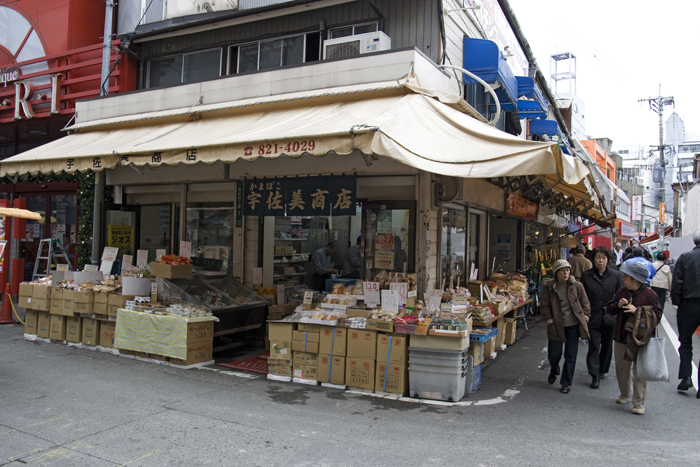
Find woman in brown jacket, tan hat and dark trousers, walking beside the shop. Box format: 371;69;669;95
540;259;591;394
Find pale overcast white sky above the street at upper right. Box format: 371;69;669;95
509;0;700;148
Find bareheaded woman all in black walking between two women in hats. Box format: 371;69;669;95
581;245;622;389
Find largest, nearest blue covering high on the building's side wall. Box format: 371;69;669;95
463;37;518;105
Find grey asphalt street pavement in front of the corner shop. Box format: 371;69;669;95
0;303;700;466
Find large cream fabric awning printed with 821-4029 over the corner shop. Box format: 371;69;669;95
0;79;590;186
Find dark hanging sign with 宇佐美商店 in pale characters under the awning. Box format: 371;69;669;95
243;176;357;216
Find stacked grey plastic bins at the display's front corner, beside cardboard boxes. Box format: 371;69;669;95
408;356;473;402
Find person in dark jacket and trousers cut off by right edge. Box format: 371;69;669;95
671;229;700;399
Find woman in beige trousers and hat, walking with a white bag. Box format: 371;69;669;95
606;263;663;415
